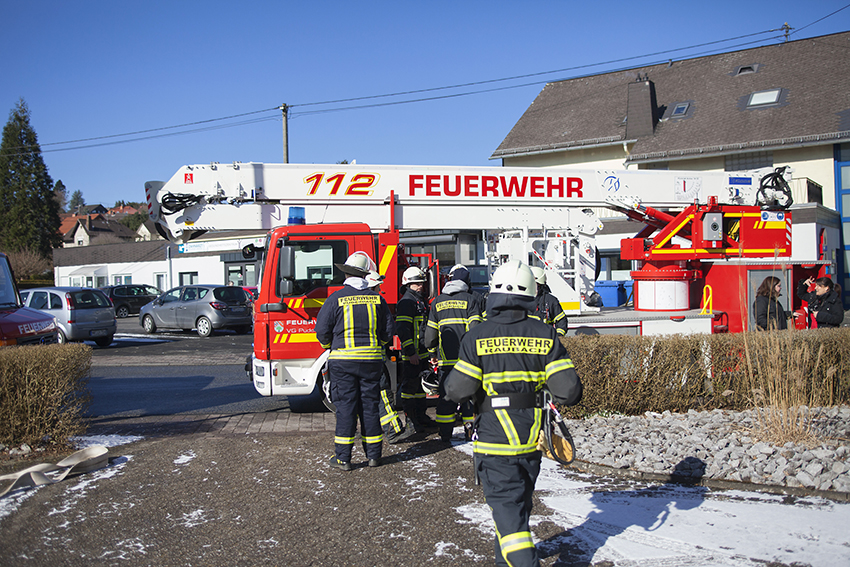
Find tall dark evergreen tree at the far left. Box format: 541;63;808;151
0;99;62;258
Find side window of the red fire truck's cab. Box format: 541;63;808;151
287;240;348;295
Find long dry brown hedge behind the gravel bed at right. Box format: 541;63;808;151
562;329;850;417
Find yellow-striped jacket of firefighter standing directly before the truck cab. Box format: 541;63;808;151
316;284;394;361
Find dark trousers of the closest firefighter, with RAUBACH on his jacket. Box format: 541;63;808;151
476;451;542;567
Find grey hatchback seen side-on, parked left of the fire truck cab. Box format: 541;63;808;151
139;285;252;337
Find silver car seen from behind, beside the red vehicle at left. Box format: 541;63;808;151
21;287;118;347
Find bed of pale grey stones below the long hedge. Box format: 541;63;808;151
568;406;850;492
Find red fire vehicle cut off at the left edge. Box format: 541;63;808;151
0;252;56;346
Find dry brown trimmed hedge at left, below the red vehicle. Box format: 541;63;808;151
0;344;91;447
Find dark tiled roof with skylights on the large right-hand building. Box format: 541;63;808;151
491;32;850;162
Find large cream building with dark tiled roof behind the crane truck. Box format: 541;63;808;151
491;32;850;304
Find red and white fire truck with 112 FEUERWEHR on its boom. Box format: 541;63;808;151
145;162;825;408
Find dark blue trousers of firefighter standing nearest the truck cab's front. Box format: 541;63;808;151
328;359;384;463
